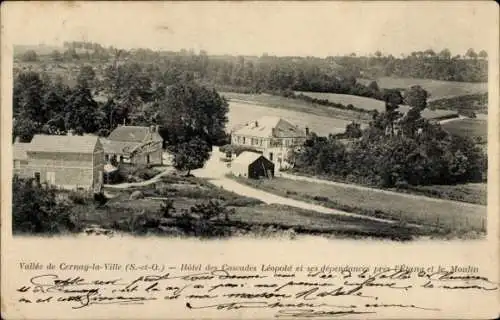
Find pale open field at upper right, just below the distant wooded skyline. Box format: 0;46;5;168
358;77;488;100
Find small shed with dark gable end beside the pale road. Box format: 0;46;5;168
231;151;274;179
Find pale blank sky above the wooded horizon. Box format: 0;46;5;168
1;1;498;57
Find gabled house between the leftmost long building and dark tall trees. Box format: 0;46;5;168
101;126;163;165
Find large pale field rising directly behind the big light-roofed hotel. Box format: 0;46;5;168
222;92;366;135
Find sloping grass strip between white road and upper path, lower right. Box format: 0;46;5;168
231;178;486;232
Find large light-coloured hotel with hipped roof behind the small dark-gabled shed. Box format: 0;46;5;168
231;116;309;170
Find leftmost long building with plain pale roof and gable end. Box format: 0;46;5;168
13;135;104;192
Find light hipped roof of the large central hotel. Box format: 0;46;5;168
234;116;306;138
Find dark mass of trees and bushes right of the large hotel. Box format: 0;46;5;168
292;86;487;188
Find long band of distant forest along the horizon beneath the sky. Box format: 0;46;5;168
16;42;488;94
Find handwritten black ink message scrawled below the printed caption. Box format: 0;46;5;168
16;268;498;318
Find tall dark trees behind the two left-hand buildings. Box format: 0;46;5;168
13;64;229;173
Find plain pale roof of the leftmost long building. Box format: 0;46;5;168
27;134;99;153
